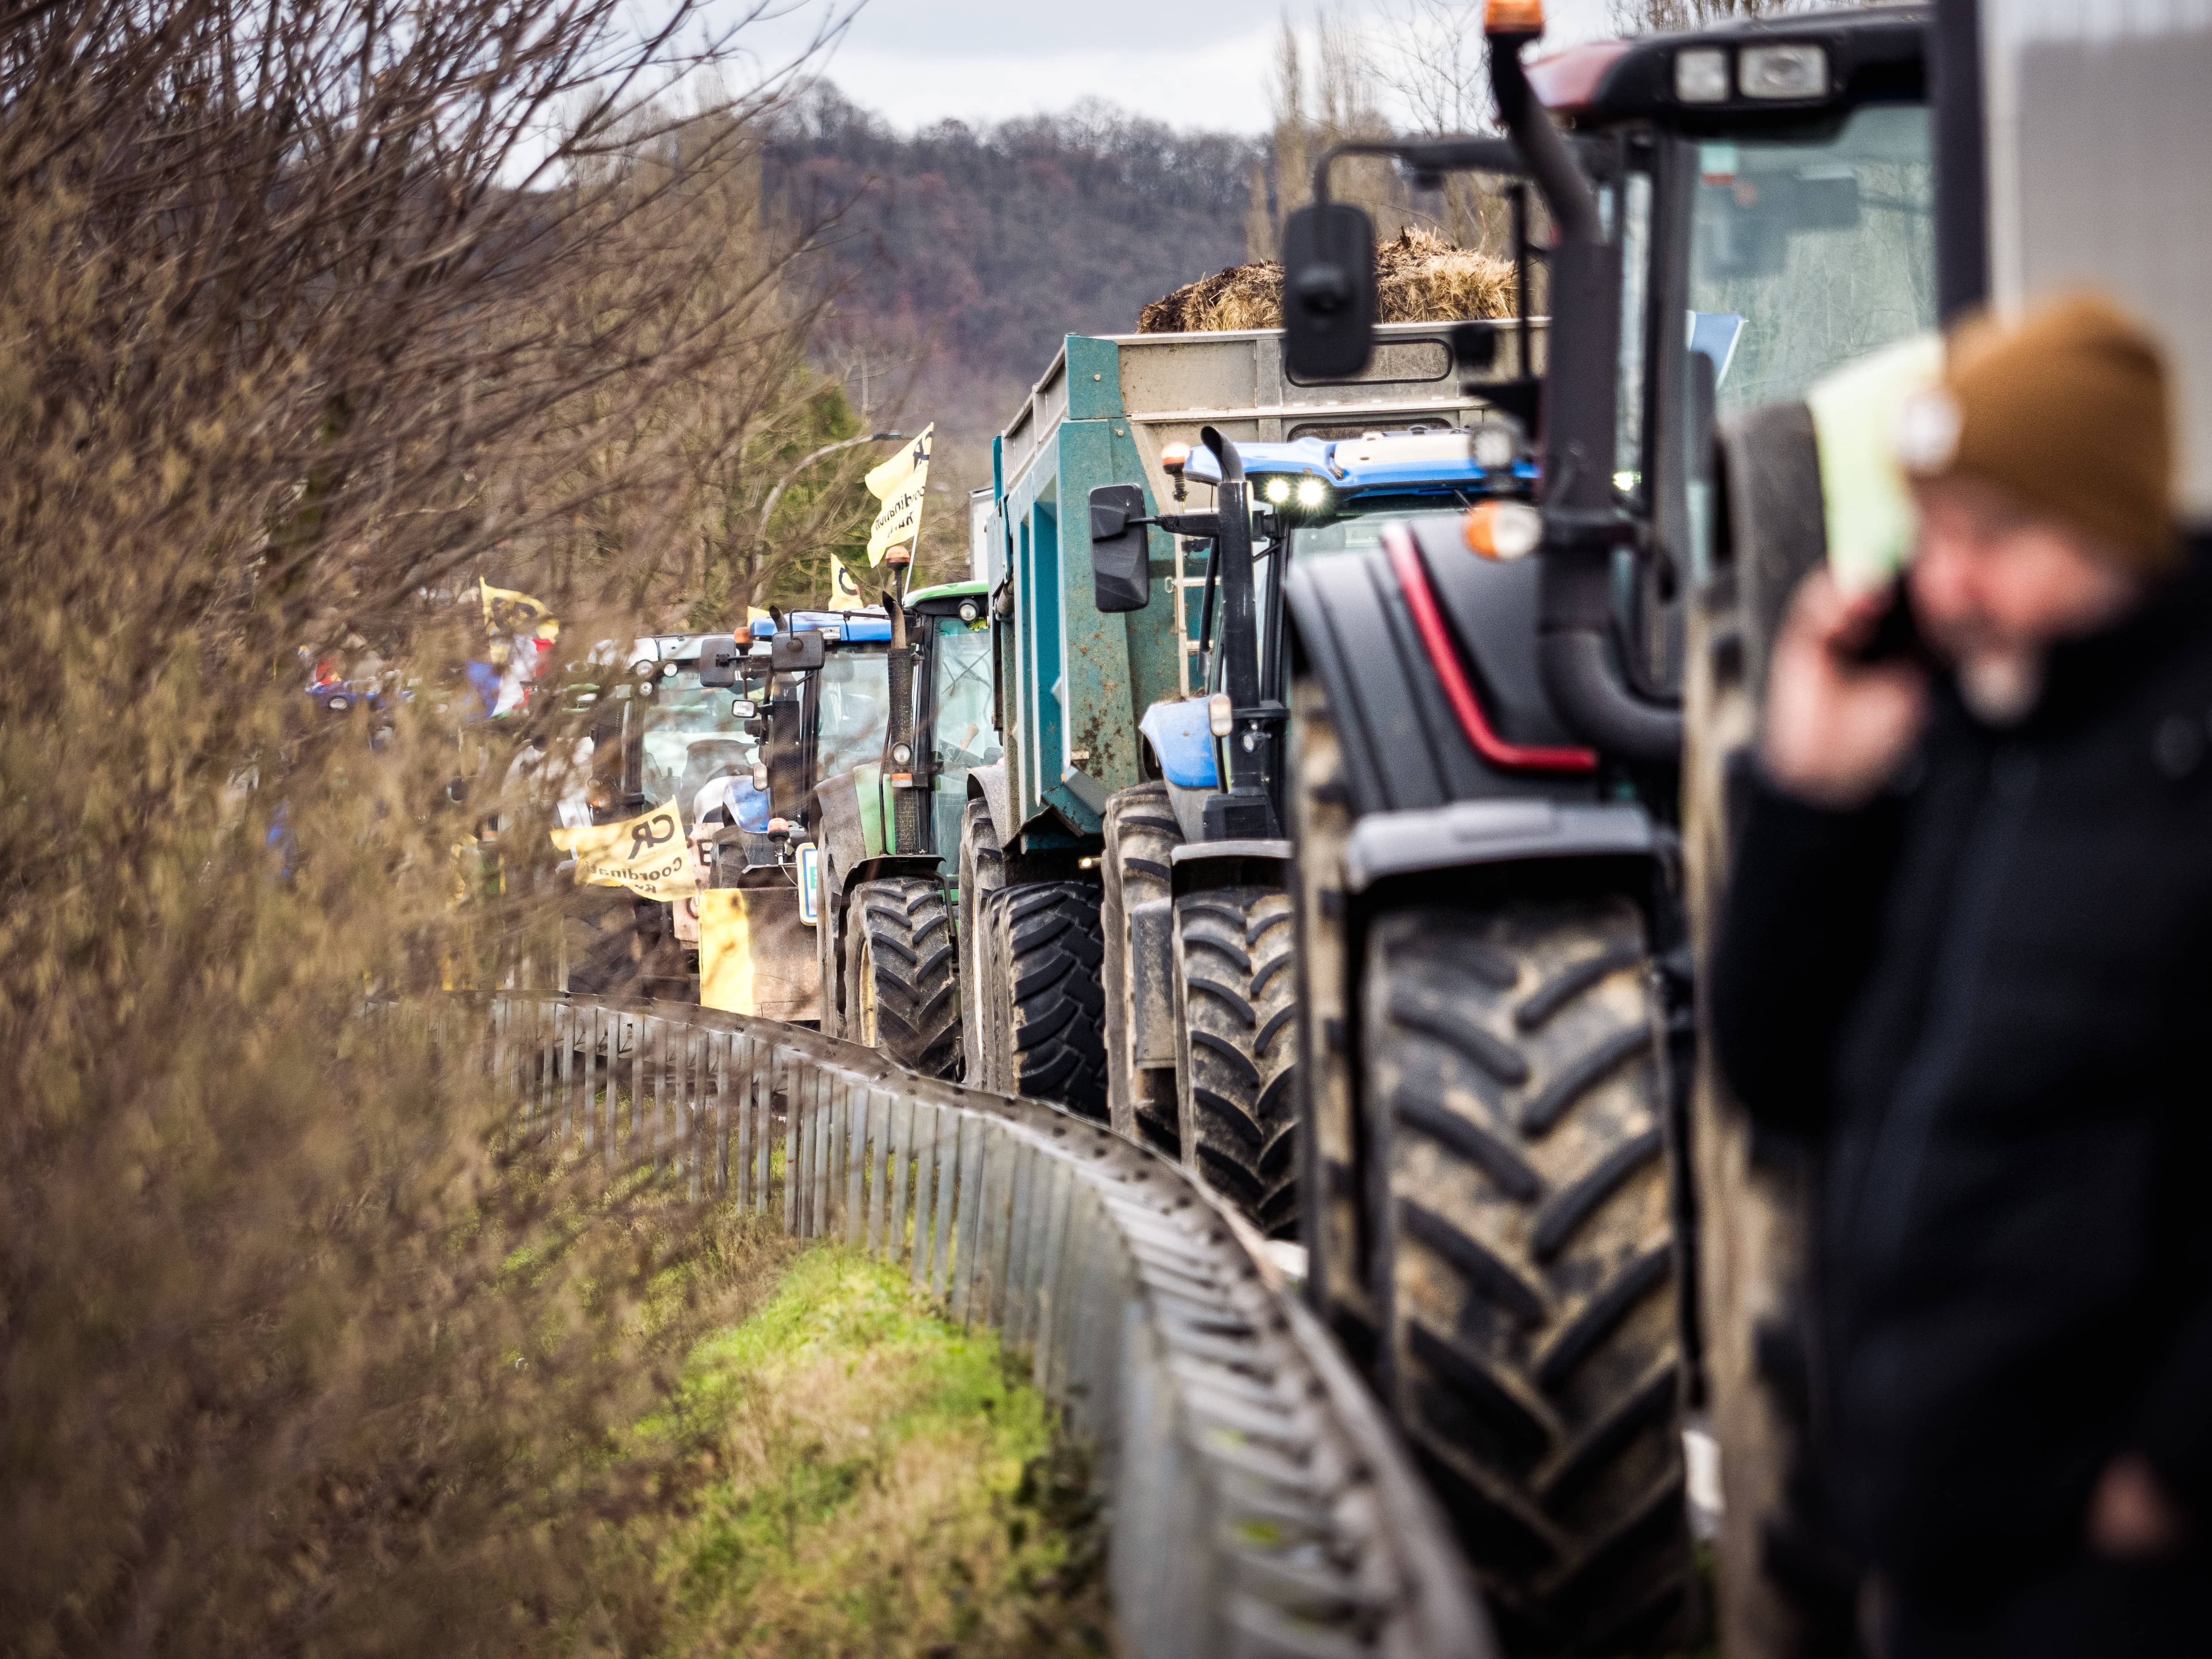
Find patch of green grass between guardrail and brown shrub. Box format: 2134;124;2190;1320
661;1245;1108;1659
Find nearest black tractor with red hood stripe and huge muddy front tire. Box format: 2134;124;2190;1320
1285;7;1936;1652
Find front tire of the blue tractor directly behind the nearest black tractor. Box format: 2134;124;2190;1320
1175;887;1298;1239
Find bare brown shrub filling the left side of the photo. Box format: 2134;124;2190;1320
0;0;854;1655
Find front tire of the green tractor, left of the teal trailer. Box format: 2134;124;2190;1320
845;876;960;1077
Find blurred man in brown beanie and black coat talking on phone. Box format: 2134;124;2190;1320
1712;299;2212;1659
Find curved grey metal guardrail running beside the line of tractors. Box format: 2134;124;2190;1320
491;995;1498;1659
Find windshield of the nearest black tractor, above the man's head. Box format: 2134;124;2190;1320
1688;104;1936;409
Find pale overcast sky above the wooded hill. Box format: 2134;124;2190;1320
719;0;1610;133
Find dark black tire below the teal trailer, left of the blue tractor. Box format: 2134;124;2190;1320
980;880;1106;1121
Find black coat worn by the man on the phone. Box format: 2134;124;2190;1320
1710;568;2212;1593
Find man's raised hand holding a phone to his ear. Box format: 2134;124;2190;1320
1761;571;1929;810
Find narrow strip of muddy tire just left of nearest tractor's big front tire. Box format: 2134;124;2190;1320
1290;675;1382;1382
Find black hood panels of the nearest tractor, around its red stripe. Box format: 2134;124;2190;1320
1285;520;1597;816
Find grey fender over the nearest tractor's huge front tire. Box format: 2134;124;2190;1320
1345;799;1663;894
